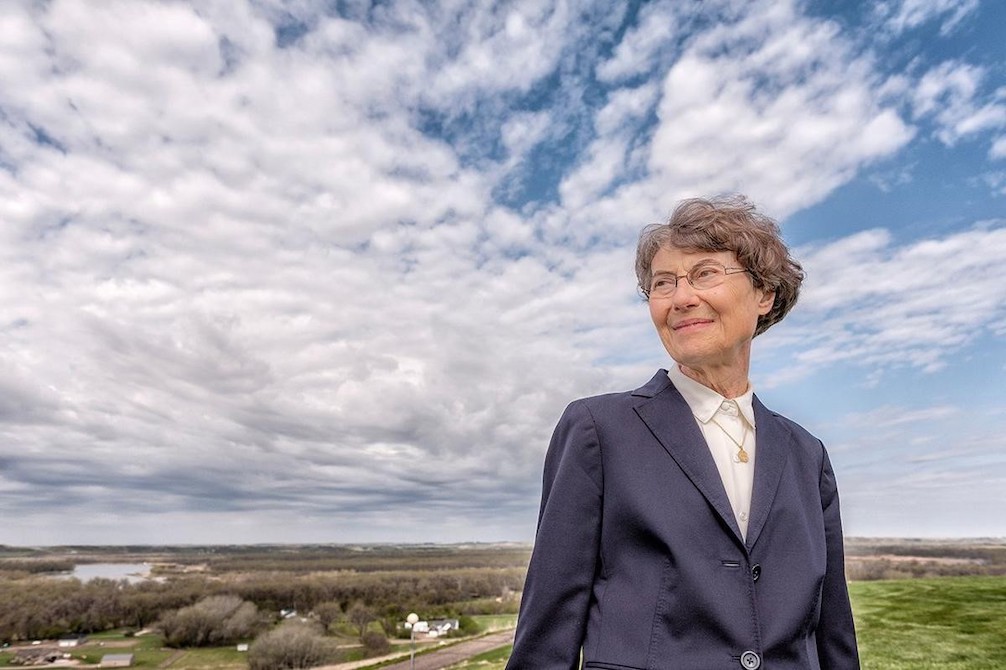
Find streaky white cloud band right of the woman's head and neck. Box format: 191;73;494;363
763;223;1006;385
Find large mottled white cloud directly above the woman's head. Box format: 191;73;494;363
591;3;912;227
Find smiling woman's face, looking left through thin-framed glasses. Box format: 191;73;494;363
649;246;776;375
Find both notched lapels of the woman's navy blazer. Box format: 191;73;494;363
632;369;791;547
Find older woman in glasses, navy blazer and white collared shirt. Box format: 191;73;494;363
507;196;859;670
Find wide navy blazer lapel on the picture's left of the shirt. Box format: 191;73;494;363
633;370;744;543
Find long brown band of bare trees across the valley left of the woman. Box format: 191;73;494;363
0;567;524;642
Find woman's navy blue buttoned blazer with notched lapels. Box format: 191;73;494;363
507;370;859;670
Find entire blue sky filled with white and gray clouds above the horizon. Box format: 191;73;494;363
0;0;1006;546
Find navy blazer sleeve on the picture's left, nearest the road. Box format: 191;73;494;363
506;400;603;670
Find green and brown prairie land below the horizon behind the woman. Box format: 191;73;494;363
0;538;1006;670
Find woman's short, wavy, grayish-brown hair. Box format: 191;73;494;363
636;194;805;335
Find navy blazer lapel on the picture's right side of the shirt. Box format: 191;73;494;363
747;396;792;547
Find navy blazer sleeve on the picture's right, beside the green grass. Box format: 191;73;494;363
816;447;859;670
